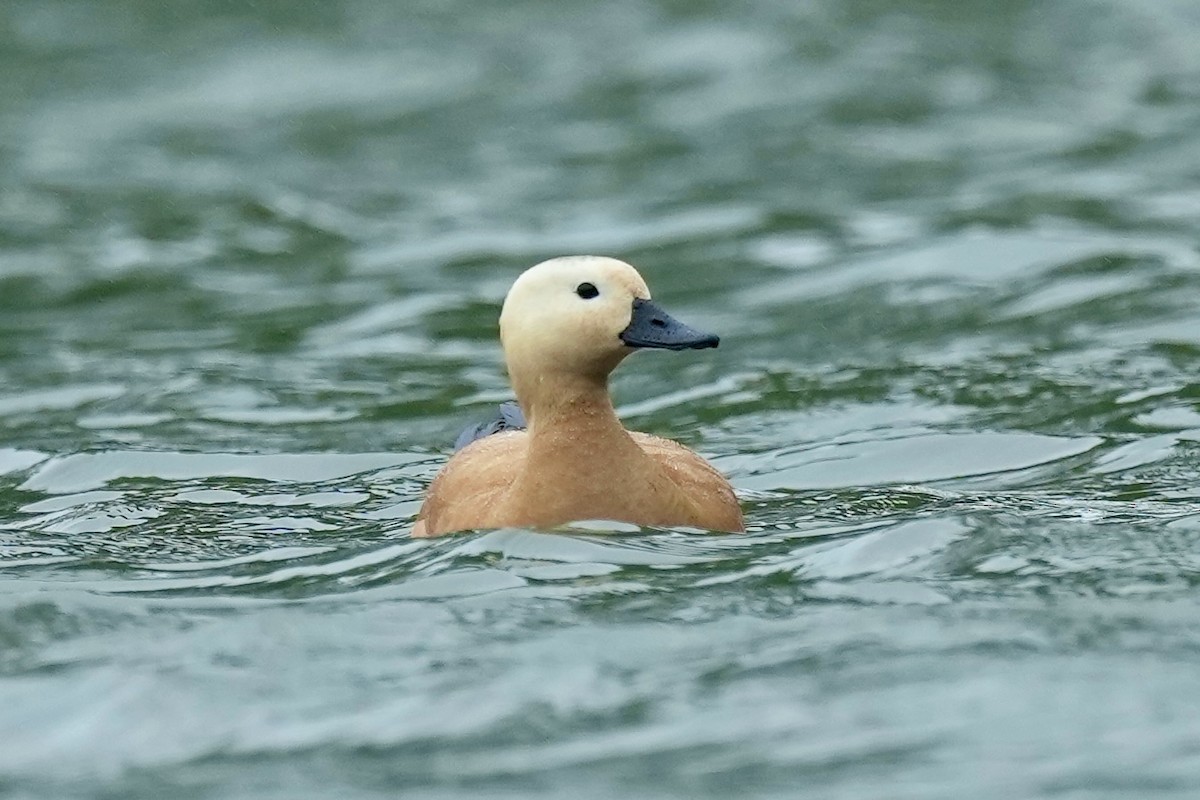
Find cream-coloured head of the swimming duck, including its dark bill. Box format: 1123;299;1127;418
500;255;720;378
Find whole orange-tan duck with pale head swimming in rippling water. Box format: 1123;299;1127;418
412;255;745;537
